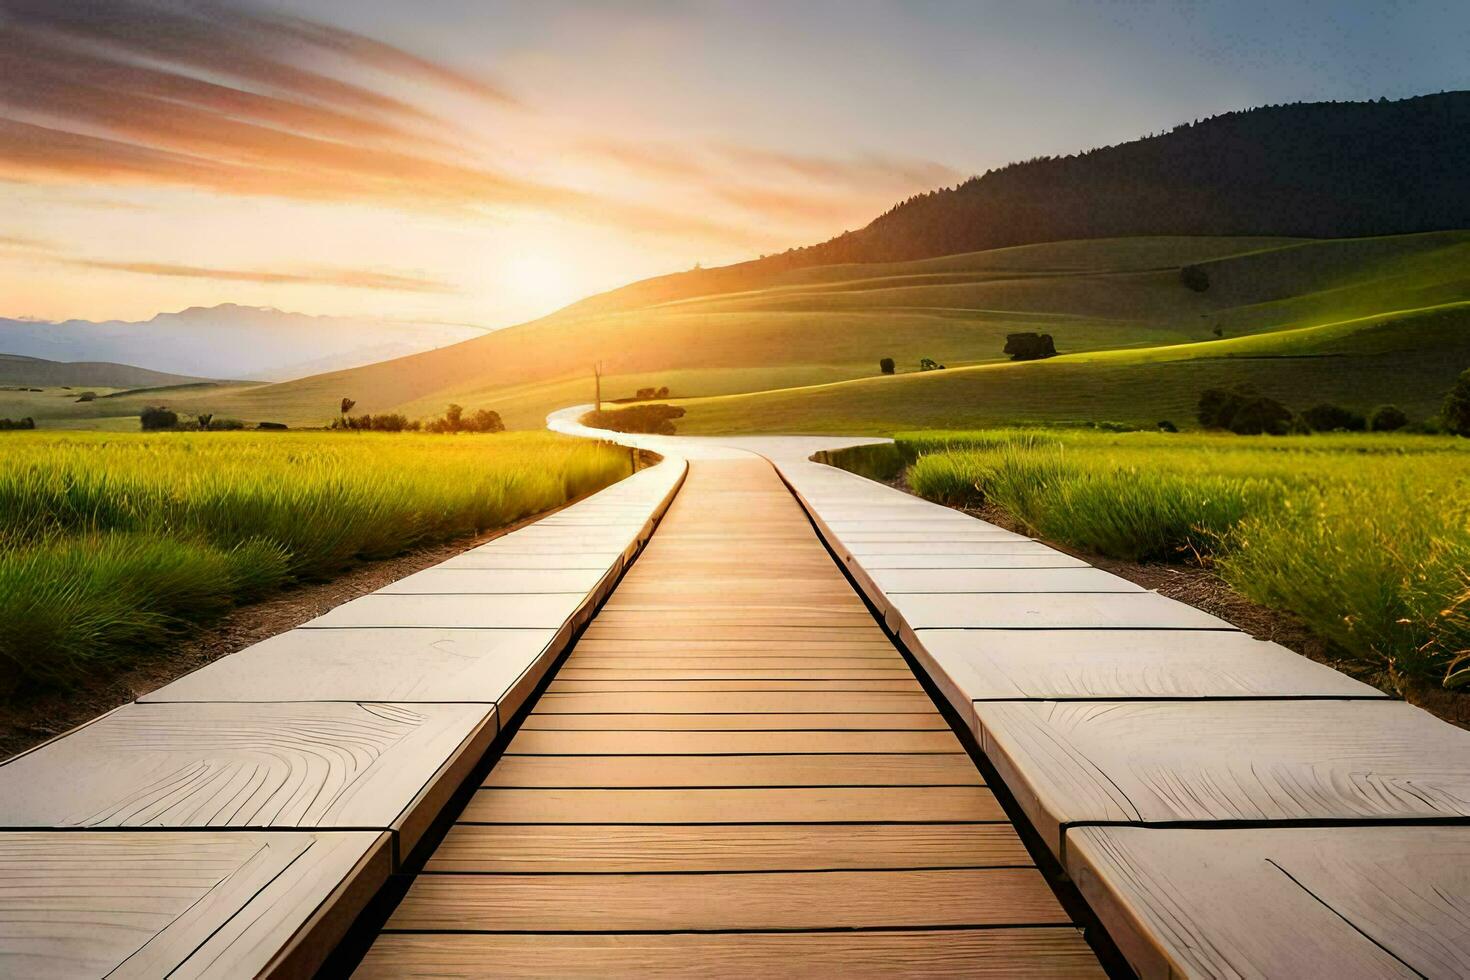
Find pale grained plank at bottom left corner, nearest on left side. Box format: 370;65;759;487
0;832;390;977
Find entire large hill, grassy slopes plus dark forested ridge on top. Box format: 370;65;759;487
14;94;1470;430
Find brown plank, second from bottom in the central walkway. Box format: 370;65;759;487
387;868;1069;933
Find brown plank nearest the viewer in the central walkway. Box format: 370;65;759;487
354;929;1105;980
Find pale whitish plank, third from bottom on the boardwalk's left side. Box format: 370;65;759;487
140;629;557;702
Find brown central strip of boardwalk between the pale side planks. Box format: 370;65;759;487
357;458;1103;977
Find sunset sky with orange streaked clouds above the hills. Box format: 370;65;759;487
0;0;1470;328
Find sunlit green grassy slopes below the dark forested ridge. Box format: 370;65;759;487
22;232;1470;432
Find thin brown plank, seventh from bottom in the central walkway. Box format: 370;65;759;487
520;711;950;732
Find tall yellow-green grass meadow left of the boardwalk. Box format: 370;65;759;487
0;432;629;695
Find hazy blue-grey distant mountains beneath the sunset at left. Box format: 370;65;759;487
0;303;484;383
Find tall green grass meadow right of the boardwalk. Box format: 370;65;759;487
836;429;1470;686
